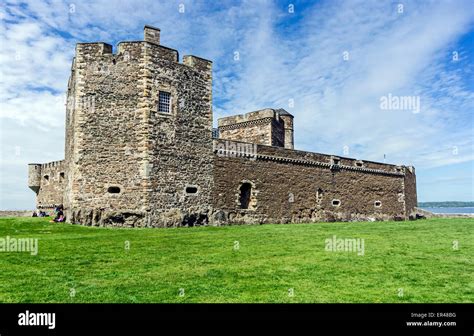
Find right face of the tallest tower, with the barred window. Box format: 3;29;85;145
146;50;213;227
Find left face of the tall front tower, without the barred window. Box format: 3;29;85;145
66;42;148;225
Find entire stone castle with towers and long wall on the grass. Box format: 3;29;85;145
28;26;417;227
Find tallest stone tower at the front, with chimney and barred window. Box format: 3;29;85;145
64;26;213;226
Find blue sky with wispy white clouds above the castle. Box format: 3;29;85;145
0;0;474;210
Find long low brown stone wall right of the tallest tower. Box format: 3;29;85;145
213;140;416;223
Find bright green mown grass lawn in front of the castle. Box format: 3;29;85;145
0;218;474;302
